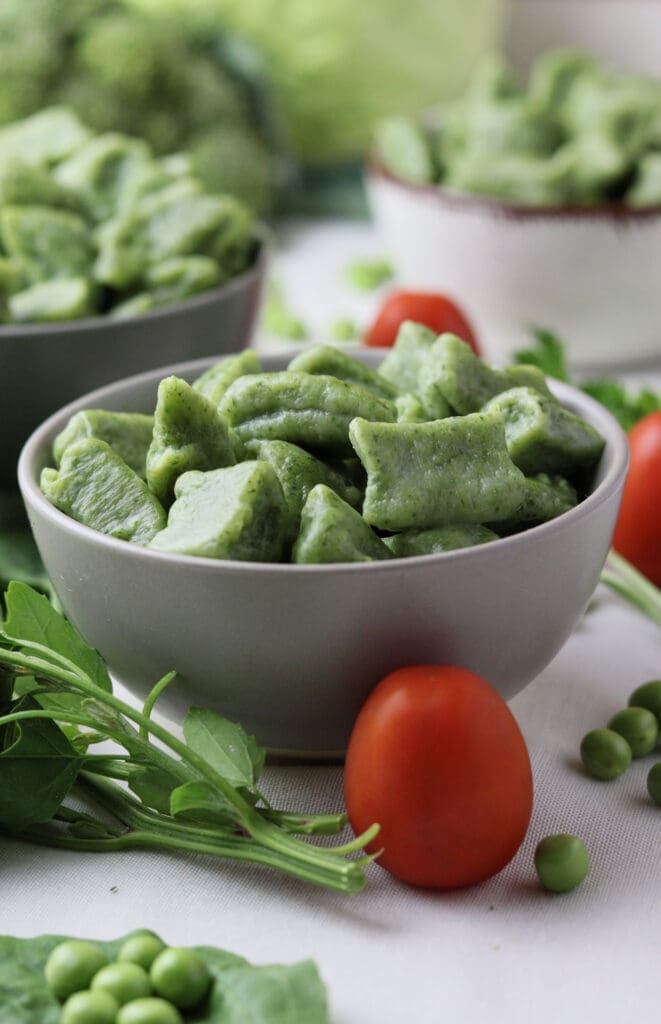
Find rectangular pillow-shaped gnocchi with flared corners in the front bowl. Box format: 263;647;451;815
349;410;525;531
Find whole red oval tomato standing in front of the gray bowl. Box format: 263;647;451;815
345;665;532;889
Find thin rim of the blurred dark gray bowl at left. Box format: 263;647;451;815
0;223;271;342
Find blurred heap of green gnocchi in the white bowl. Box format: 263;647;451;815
377;50;661;208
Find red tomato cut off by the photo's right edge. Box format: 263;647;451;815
613;412;661;587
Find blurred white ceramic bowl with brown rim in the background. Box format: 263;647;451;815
367;166;661;370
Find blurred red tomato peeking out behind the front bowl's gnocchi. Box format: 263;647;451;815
364;292;481;355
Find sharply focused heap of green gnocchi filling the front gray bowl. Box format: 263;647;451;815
41;322;604;563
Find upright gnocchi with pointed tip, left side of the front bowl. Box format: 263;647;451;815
146;376;236;506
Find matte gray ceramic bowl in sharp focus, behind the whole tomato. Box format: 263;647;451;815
18;349;627;757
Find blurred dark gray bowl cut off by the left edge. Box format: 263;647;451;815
0;239;268;490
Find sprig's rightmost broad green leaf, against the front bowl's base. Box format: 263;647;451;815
183;708;265;790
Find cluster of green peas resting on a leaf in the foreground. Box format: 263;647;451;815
45;933;212;1024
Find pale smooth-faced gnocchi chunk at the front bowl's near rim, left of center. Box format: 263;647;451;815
149;460;288;562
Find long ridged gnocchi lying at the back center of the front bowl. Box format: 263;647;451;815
219;370;397;455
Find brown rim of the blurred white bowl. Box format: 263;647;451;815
366;156;661;221
